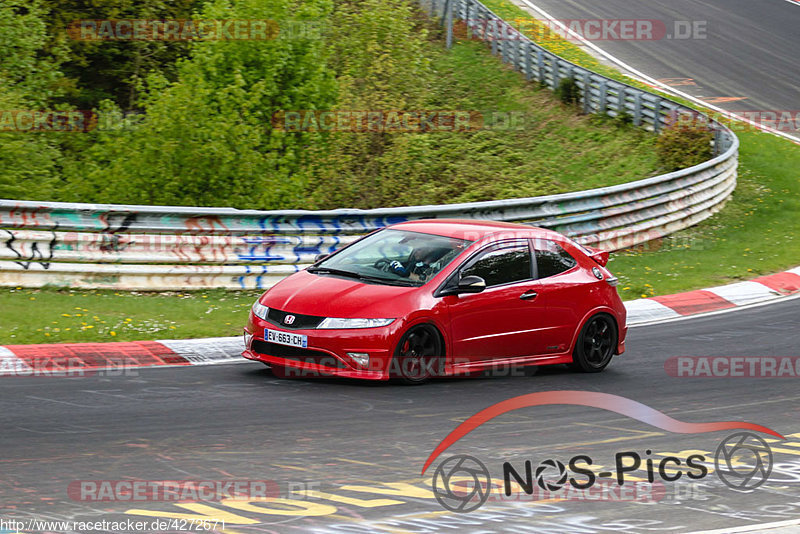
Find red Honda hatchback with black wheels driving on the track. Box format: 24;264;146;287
243;219;627;384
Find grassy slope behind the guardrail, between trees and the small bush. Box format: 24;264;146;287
306;36;662;209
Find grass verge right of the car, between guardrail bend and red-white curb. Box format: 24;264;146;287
609;127;800;300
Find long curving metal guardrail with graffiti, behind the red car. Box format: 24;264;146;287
0;0;739;290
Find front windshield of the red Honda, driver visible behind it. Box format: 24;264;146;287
308;229;473;286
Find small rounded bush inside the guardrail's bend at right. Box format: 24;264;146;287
656;119;714;172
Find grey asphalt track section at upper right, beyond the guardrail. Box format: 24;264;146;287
515;0;800;136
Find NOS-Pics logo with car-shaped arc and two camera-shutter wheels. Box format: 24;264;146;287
422;391;785;513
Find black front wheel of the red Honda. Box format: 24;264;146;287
392;324;443;385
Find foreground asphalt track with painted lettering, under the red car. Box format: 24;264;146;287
0;298;800;533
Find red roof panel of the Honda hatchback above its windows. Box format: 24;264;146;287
391;219;563;241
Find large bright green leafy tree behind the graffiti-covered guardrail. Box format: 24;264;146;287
64;0;335;208
